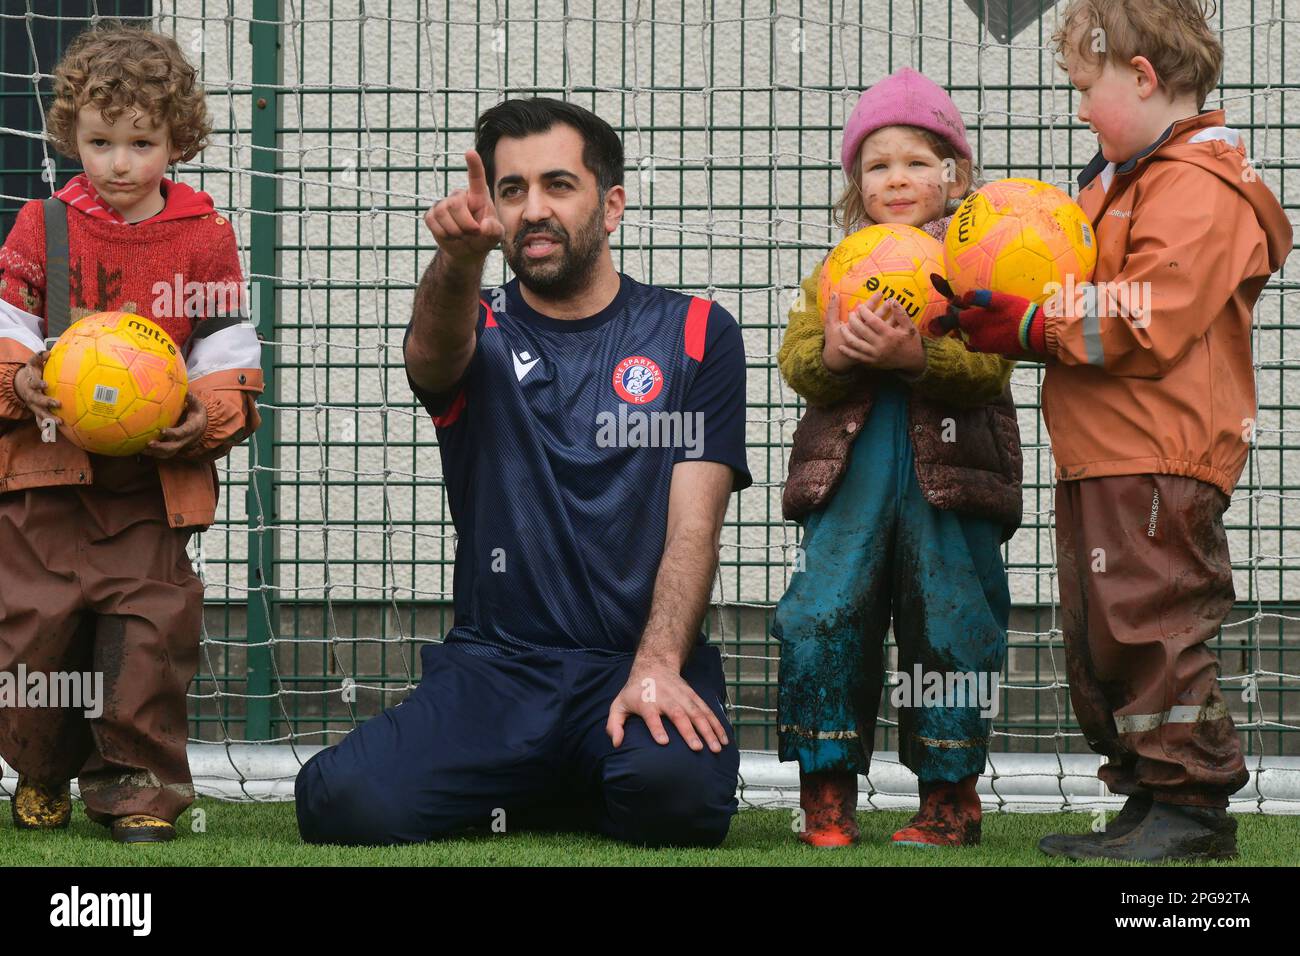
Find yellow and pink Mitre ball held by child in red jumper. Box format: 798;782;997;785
44;312;189;457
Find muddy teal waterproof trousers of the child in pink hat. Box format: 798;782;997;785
772;382;1010;782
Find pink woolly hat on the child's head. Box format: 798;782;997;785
840;66;972;176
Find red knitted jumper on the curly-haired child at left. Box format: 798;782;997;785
0;177;243;347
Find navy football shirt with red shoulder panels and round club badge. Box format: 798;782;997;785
403;276;751;653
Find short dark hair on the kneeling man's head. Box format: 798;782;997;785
475;96;623;196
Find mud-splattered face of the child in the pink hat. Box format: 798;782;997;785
858;126;962;226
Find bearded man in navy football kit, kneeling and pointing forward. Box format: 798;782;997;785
289;99;750;845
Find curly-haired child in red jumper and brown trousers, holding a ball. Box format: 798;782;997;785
0;23;263;843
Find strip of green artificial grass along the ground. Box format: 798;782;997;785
0;800;1300;866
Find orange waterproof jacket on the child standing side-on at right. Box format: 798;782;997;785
1043;109;1291;494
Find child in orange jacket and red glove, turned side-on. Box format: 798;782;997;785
952;0;1294;862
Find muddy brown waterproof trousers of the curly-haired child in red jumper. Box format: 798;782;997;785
0;477;203;823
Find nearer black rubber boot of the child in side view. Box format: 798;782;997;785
1065;803;1236;862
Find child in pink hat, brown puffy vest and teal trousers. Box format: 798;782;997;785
772;68;1021;847
